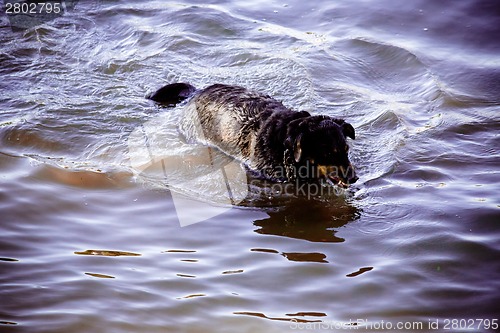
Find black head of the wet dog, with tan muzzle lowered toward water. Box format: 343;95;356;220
285;116;358;188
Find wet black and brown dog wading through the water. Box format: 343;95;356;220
147;83;358;188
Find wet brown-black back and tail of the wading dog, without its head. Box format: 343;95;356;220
149;83;294;168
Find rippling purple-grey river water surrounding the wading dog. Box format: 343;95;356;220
0;0;500;333
